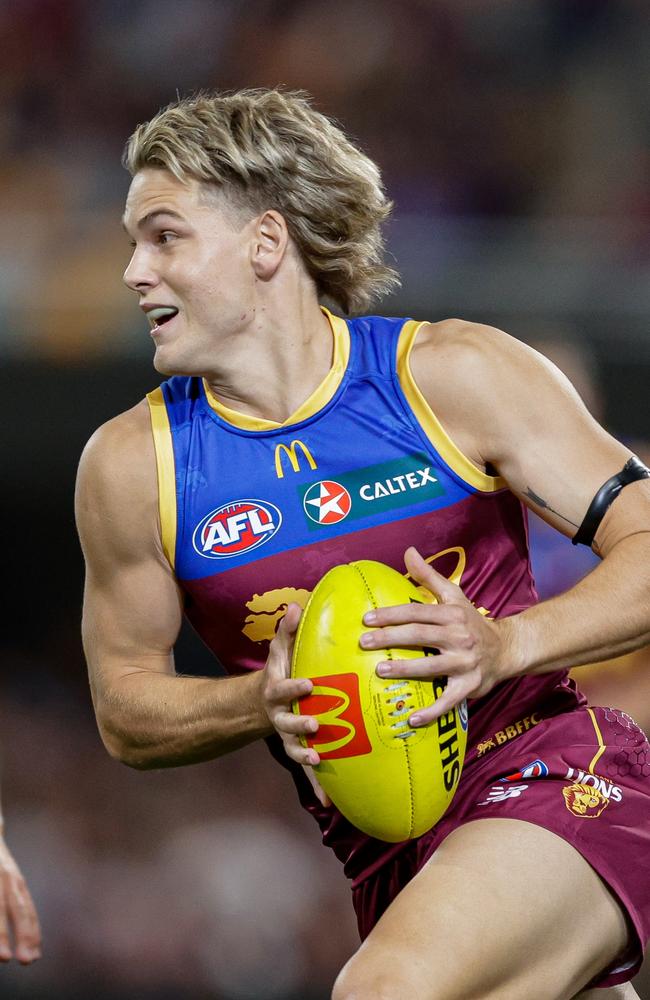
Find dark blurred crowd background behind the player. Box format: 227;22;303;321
0;0;650;1000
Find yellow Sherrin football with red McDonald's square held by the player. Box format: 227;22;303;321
291;560;467;843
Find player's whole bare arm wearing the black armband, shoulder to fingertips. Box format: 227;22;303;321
362;321;650;721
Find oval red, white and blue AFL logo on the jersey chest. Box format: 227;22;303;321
192;500;282;559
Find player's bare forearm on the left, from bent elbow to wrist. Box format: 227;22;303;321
94;670;272;769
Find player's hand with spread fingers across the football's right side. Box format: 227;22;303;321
360;548;513;726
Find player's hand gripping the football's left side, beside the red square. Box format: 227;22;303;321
262;604;320;767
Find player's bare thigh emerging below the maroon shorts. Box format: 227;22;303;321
333;819;628;1000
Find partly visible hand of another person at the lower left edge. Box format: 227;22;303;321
0;832;41;965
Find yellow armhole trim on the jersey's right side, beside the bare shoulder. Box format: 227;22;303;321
397;320;506;493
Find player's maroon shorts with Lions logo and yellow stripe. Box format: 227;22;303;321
353;708;650;986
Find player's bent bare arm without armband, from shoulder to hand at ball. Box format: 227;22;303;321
76;404;312;768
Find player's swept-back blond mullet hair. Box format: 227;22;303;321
123;89;399;312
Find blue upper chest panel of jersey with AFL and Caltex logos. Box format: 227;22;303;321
163;317;474;580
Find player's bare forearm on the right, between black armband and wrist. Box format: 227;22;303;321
498;532;650;673
